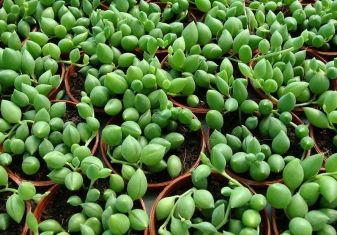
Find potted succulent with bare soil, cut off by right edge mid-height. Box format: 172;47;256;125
304;91;337;159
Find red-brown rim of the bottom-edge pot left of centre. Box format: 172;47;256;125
30;185;148;235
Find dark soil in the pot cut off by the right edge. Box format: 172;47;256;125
314;128;337;156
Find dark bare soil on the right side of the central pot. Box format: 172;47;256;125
147;126;202;183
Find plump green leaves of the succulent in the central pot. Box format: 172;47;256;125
102;98;201;180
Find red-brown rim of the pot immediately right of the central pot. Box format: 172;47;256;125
206;113;311;188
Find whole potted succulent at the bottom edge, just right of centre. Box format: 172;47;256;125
150;155;271;235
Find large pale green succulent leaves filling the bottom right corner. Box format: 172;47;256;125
266;154;337;235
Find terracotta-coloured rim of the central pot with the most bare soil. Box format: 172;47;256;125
100;120;206;190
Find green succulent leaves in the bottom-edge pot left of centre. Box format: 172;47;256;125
27;171;148;235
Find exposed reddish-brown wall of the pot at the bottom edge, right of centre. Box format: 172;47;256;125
150;172;271;235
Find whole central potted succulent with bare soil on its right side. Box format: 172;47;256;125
101;91;205;189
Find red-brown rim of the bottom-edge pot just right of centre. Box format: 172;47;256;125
149;172;271;235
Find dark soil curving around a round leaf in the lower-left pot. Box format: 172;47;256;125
9;155;50;181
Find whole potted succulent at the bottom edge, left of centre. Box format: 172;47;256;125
28;161;148;235
